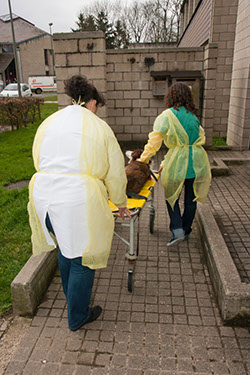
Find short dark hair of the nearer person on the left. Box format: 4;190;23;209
64;74;105;106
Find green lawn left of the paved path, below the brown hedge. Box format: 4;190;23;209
0;104;58;315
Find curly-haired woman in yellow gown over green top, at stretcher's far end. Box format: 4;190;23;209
138;83;211;246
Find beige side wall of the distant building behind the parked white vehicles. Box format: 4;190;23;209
20;34;53;83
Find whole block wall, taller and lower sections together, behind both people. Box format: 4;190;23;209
54;32;212;144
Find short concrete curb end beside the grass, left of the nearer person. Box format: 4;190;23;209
11;249;58;316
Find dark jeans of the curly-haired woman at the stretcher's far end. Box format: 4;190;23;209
166;178;197;235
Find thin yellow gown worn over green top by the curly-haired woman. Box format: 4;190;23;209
139;109;211;209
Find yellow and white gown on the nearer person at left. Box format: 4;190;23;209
28;105;127;269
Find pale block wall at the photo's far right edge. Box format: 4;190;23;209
227;0;250;149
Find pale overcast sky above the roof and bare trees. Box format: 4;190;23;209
0;0;133;33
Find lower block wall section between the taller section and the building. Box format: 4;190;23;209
107;48;203;141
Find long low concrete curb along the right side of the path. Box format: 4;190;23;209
196;204;250;325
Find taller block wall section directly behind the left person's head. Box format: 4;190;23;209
53;31;107;119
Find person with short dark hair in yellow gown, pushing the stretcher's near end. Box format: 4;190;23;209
28;75;130;331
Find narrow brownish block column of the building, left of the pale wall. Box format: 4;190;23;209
209;0;238;137
